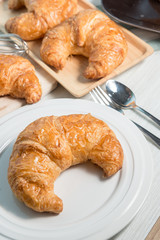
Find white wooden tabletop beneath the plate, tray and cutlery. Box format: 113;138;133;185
0;0;160;240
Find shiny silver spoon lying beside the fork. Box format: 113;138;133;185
106;80;160;126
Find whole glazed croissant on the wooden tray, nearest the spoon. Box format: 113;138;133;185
41;9;127;79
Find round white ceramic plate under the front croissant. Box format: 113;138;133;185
0;99;152;240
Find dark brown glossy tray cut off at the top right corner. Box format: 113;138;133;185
102;0;160;33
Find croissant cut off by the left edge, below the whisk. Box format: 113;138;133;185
0;54;42;103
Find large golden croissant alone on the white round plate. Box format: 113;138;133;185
8;114;123;213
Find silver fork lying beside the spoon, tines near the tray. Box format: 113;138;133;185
90;86;160;147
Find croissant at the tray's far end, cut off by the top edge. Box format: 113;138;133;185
5;0;77;40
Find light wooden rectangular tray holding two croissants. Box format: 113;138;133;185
0;0;153;97
